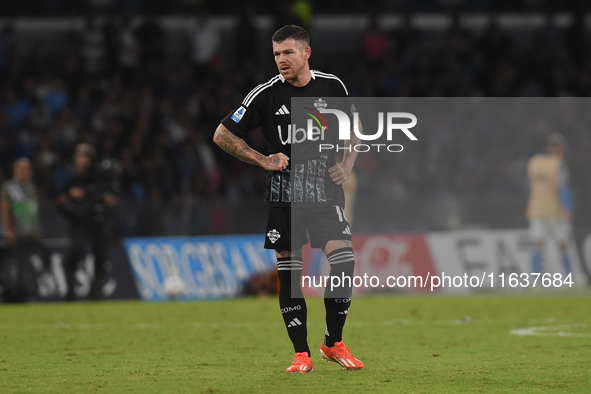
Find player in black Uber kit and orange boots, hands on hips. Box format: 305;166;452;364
214;25;363;373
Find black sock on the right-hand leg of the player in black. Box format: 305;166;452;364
324;248;355;347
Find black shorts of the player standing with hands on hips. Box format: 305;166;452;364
265;205;351;250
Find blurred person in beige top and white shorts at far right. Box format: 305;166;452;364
526;133;573;275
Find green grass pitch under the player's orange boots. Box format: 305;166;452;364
0;292;591;393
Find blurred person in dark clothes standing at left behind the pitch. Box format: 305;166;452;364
58;143;118;301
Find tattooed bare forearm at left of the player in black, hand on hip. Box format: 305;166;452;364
213;124;289;171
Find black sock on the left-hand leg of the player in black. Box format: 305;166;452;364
277;257;310;356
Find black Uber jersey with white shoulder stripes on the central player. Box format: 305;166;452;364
222;70;348;207
